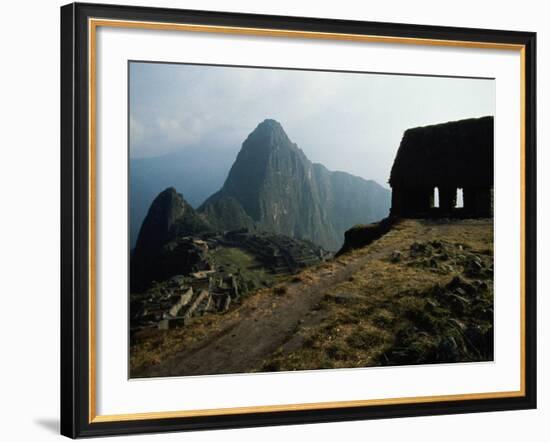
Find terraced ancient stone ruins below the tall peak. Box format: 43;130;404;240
130;229;332;333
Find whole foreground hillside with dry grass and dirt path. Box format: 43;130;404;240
130;219;493;377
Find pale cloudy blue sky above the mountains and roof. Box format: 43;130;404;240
129;62;495;187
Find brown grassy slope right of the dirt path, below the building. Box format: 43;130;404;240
260;220;493;371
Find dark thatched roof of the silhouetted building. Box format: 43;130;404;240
389;117;494;187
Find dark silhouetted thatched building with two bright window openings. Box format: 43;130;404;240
389;117;494;218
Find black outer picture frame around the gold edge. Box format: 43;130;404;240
61;3;536;438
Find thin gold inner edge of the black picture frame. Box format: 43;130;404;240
88;18;526;423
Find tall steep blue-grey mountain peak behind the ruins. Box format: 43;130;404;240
198;119;390;251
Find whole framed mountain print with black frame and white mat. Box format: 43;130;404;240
61;4;536;438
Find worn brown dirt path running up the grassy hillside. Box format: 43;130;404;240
147;248;391;376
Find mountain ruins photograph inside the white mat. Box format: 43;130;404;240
128;60;498;379
